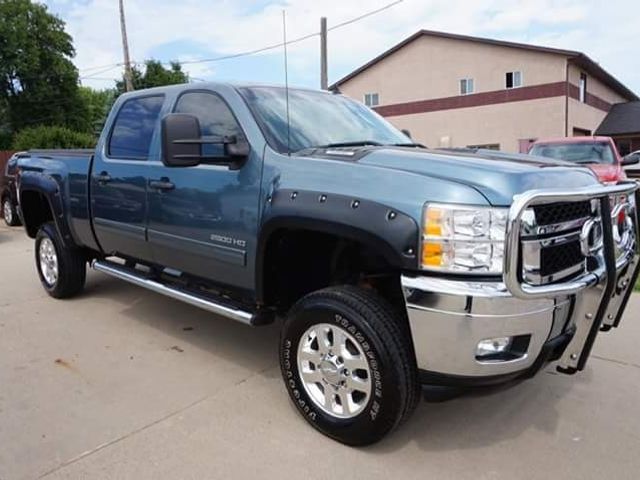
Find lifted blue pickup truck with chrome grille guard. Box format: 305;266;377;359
17;83;639;445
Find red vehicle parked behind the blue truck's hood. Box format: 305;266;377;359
529;137;631;184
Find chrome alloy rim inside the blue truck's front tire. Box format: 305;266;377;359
297;323;372;418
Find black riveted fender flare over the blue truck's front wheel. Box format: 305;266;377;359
255;189;420;303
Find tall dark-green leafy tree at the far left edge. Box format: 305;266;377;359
0;0;90;131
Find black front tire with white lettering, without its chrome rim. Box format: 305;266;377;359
280;286;419;446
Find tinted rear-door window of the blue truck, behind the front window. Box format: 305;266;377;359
109;96;164;160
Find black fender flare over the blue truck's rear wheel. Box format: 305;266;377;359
18;170;75;246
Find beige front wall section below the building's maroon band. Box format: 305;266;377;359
387;97;565;152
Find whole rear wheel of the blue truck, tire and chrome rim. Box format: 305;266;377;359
35;223;87;298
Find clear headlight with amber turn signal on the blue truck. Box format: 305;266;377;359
421;203;509;274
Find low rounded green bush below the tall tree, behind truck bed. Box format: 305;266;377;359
13;125;96;150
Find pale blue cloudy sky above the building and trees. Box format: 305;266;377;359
44;0;640;93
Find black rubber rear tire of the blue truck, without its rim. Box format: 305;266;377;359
35;223;87;298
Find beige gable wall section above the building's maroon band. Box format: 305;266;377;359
340;36;566;105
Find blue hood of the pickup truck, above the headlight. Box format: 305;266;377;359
357;147;598;206
